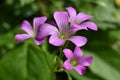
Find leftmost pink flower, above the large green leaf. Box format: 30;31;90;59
15;16;47;45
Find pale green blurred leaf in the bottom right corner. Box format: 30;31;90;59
84;49;120;80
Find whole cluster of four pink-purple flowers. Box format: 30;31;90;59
15;7;97;75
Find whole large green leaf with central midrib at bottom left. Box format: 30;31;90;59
0;44;55;80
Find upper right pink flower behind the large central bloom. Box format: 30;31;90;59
66;7;97;31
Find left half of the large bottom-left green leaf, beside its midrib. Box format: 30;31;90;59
0;47;26;80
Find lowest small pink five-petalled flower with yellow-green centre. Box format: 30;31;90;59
63;47;93;75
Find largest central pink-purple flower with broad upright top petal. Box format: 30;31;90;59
36;12;87;47
